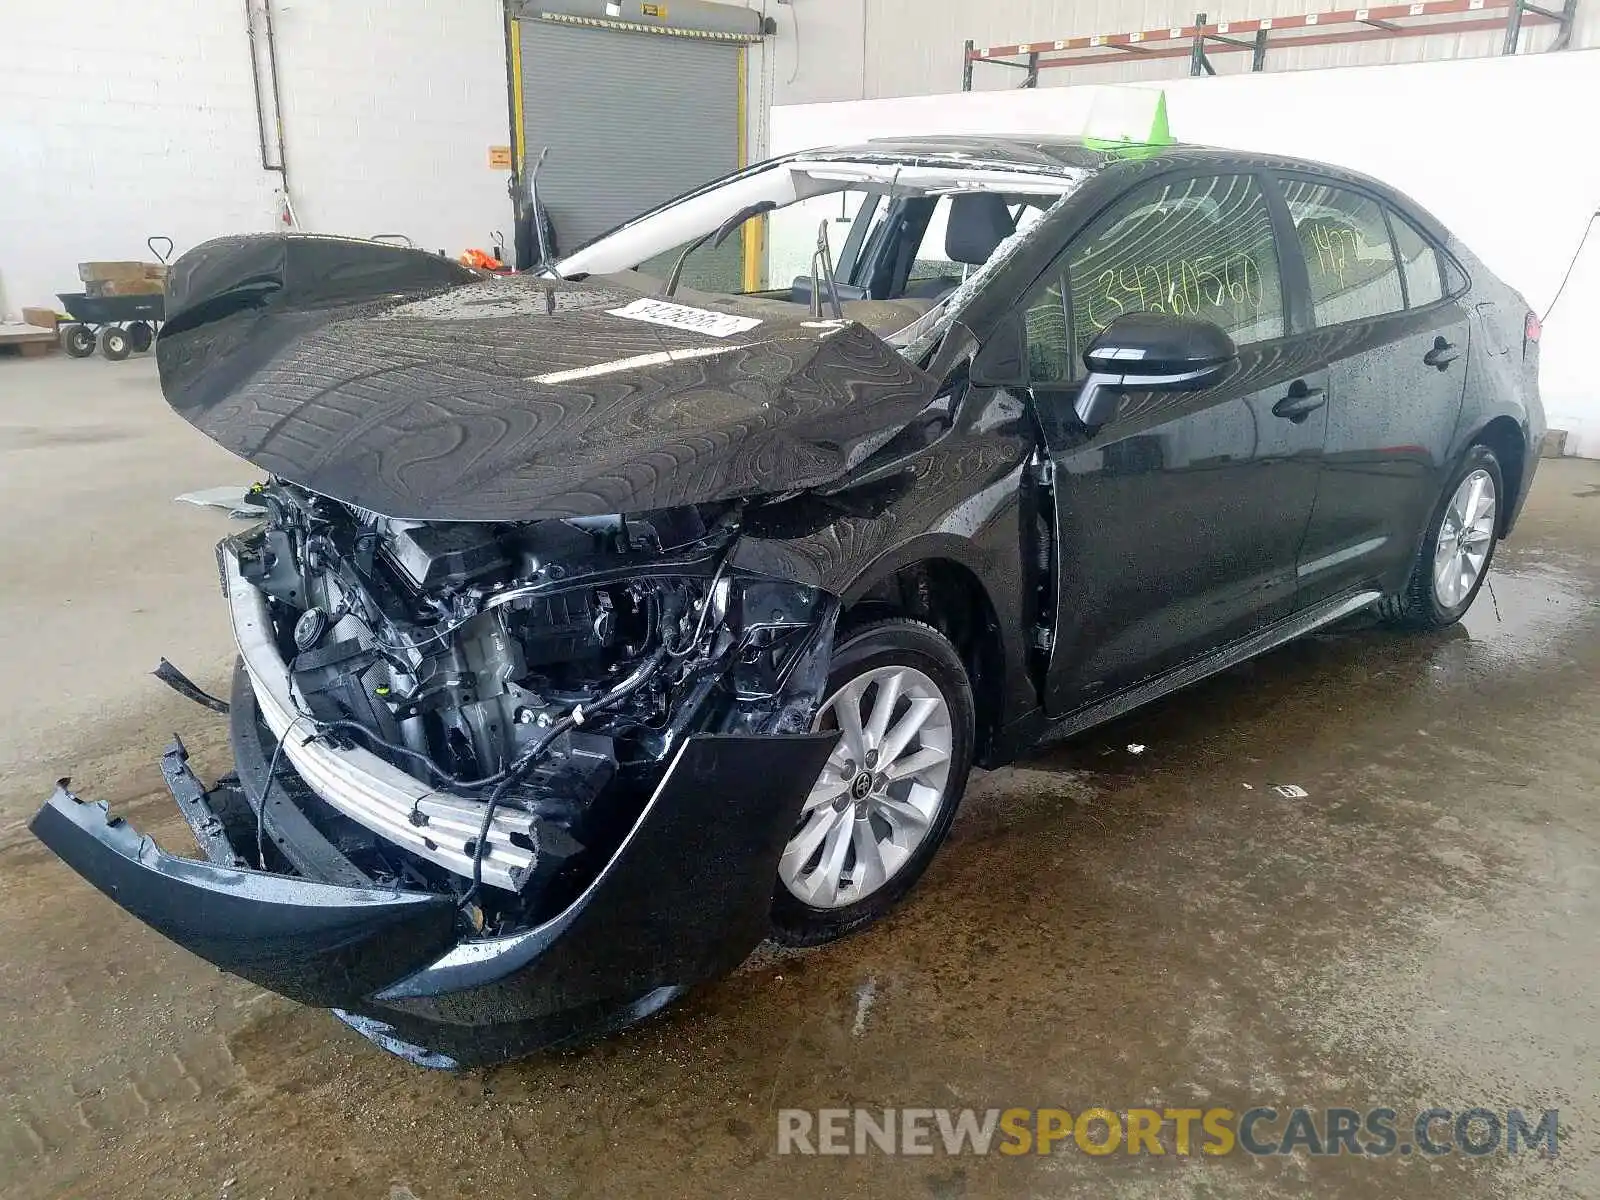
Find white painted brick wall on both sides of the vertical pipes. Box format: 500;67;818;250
0;0;510;315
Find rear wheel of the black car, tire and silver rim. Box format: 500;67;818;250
1378;446;1506;629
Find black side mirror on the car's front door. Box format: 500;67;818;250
1072;312;1238;430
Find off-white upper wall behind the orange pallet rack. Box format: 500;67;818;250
766;0;1600;104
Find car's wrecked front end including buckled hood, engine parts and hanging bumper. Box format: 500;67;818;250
34;235;972;1064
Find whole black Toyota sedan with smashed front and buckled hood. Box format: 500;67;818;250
32;138;1544;1066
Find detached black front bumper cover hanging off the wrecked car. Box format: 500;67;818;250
30;733;837;1067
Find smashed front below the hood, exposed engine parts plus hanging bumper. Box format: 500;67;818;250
34;480;838;1066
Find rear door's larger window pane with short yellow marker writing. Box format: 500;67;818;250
1283;181;1405;325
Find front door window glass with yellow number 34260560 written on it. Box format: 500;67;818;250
1026;174;1283;381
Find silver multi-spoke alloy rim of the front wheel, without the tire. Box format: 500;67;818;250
778;666;954;909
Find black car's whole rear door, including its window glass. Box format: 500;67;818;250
1280;173;1469;606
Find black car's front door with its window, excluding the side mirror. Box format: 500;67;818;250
1026;174;1326;714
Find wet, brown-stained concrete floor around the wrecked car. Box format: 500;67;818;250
0;358;1600;1200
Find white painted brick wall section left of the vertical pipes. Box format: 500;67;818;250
0;0;272;315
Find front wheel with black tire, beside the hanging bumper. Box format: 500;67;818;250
773;619;974;946
